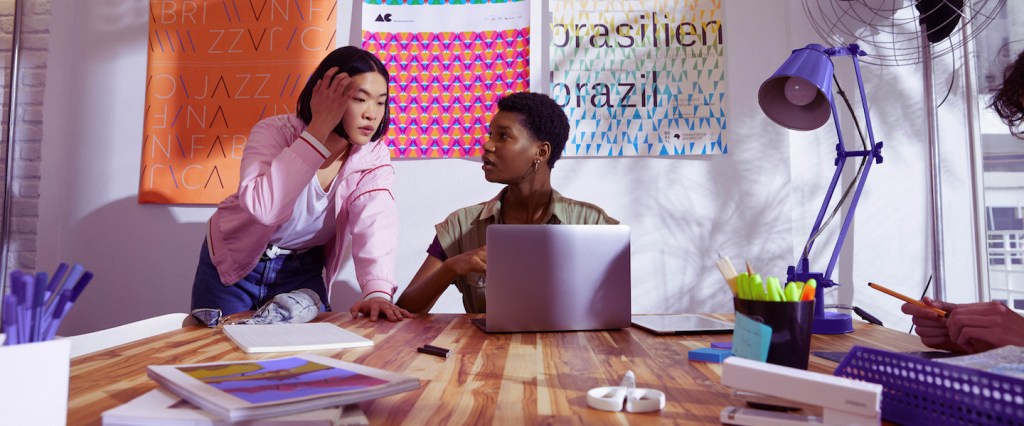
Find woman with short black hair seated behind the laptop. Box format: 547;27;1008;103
398;92;618;313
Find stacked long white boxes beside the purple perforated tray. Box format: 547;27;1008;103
719;356;882;426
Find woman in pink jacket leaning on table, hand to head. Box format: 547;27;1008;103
191;46;412;321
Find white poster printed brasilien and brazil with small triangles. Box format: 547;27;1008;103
550;0;728;157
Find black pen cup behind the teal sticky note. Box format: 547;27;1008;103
733;298;814;370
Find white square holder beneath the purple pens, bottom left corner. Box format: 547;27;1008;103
0;339;71;425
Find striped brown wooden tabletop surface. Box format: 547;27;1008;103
68;312;927;426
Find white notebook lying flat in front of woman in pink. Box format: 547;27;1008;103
224;323;374;353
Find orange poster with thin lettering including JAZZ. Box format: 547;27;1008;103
138;0;337;204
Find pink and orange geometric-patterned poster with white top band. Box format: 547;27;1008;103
362;0;529;158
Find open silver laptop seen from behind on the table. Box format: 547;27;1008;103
474;224;631;333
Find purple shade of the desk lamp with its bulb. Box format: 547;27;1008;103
758;44;834;130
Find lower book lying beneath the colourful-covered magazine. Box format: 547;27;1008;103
103;387;370;426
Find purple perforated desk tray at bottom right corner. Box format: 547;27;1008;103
836;346;1024;425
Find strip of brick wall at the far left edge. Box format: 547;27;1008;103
0;0;50;270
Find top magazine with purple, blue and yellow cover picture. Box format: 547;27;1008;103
148;353;420;422
